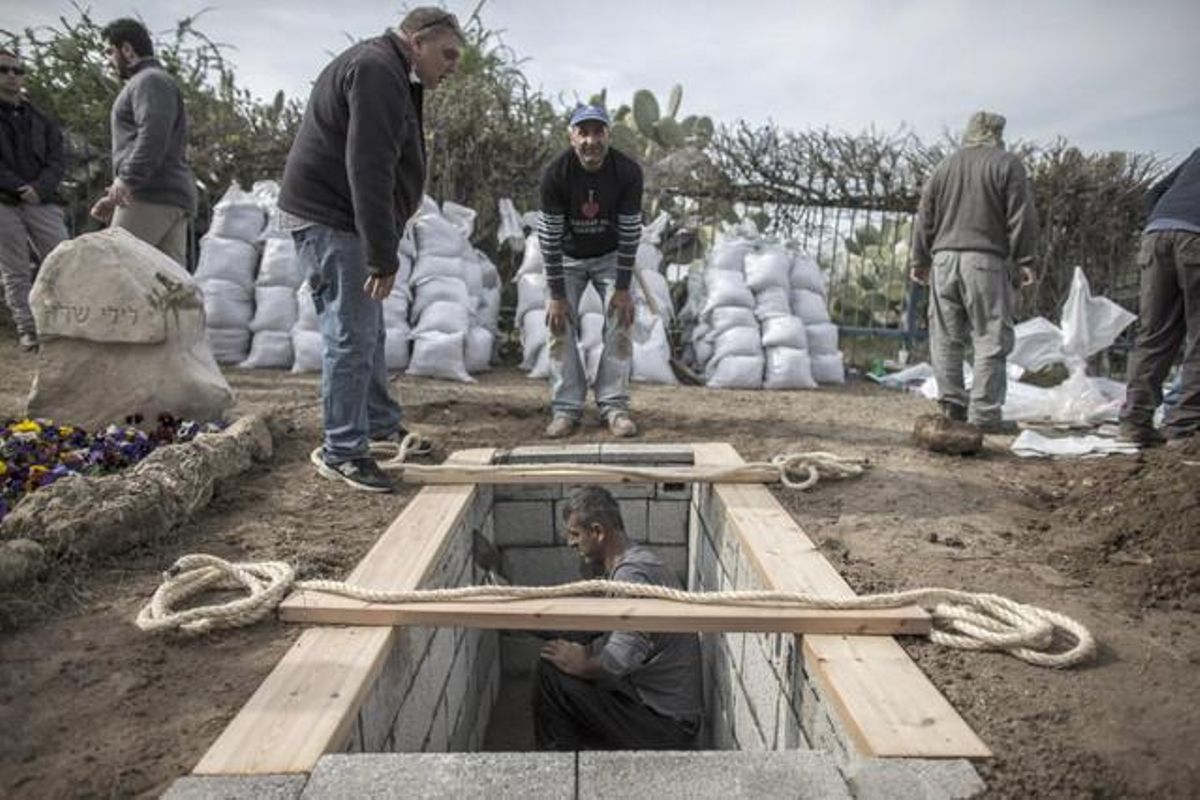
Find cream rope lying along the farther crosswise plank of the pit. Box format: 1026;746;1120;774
310;433;866;492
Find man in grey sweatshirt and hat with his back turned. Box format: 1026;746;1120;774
912;112;1038;433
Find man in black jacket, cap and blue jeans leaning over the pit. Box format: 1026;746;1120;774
280;7;463;492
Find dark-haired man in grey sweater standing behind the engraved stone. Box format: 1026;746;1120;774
91;19;196;269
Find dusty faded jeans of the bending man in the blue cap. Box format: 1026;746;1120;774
548;251;634;420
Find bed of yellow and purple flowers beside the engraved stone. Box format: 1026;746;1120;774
0;415;222;519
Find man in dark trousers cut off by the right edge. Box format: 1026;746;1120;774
1121;150;1200;446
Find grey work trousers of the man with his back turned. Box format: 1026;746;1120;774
929;249;1013;425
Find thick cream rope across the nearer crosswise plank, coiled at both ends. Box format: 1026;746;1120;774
137;554;1096;668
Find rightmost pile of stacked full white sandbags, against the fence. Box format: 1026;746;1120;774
680;225;845;389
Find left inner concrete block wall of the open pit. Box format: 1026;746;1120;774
344;486;500;753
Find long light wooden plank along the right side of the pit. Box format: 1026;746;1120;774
692;443;991;758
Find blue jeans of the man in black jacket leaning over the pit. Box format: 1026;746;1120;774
293;225;403;464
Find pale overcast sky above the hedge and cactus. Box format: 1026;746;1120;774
0;0;1200;161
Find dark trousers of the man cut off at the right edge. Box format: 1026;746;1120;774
1121;230;1200;438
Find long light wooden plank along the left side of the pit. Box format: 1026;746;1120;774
193;450;494;775
